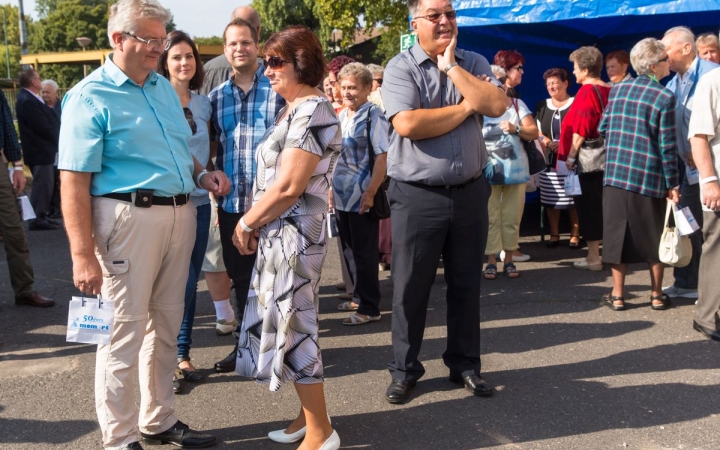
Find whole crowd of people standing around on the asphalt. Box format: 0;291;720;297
0;0;720;450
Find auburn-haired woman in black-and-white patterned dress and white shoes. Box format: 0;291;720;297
233;27;342;450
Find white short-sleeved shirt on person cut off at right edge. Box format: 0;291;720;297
688;69;720;211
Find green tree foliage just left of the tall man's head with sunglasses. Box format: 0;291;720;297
315;0;409;64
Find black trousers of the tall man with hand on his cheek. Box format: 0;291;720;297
388;177;490;381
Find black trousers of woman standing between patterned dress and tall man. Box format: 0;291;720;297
337;210;380;316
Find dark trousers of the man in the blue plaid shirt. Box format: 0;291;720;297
218;208;256;331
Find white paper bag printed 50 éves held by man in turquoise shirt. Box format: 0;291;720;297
66;296;115;345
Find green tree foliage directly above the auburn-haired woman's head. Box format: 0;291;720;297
252;0;321;42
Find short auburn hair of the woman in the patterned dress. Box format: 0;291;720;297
263;26;325;86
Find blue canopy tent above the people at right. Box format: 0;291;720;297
454;0;720;110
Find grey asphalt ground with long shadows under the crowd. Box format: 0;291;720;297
0;220;720;450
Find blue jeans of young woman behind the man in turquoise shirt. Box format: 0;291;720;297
178;204;210;358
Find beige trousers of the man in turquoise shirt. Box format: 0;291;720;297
92;197;197;449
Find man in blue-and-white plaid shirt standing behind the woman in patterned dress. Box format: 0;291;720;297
209;18;285;372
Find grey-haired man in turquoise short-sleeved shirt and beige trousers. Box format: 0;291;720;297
59;0;228;449
